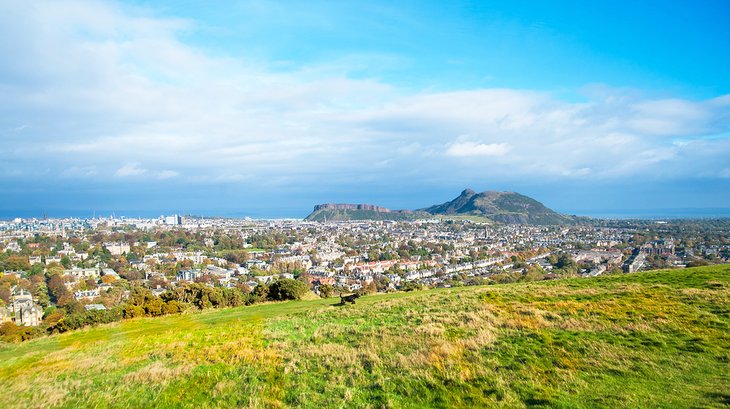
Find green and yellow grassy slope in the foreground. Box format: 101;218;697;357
0;265;730;408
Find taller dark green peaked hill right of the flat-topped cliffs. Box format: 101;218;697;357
421;189;574;225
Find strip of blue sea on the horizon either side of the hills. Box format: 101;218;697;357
0;208;730;220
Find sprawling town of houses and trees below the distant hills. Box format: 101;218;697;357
0;215;730;336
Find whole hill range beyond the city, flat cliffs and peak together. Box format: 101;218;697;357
305;189;577;225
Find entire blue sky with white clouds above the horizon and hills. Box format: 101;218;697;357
0;0;730;217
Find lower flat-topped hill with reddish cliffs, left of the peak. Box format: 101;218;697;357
304;203;430;222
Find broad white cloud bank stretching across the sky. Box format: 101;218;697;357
0;1;730;190
